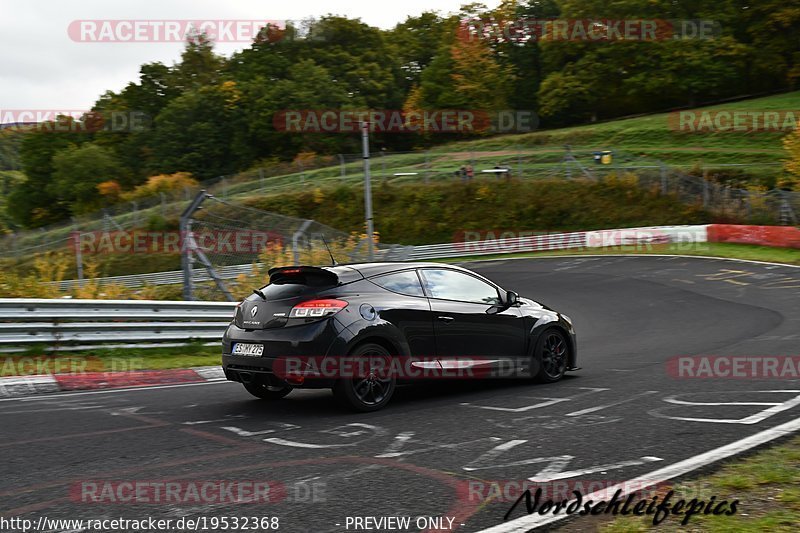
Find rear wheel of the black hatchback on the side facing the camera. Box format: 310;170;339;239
333;343;397;413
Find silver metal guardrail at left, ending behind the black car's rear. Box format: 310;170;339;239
0;298;235;352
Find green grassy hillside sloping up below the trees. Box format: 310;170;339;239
3;92;800;251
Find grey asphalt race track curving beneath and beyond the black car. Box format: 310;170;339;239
0;257;800;532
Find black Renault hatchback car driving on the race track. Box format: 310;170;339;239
222;263;577;411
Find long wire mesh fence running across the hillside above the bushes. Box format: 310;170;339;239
0;147;800;256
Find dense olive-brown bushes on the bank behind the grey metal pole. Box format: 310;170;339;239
247;179;711;244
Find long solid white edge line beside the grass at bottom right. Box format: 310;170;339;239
478;418;800;533
